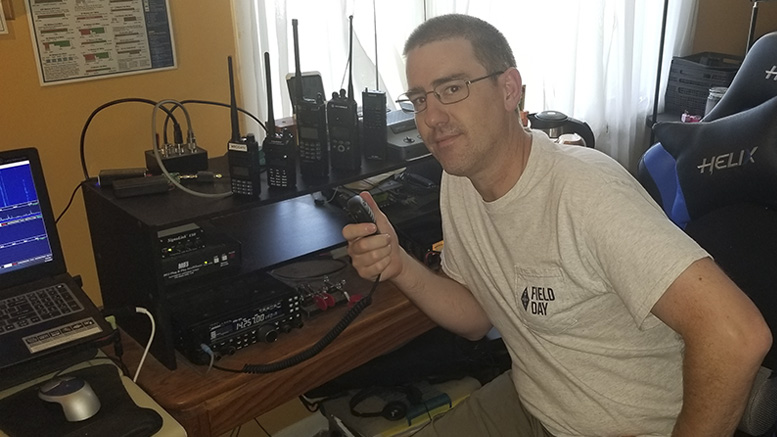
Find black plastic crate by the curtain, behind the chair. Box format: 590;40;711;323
665;52;742;115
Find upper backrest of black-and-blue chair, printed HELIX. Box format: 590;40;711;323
637;32;777;228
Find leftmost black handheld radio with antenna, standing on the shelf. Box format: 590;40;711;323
227;56;262;198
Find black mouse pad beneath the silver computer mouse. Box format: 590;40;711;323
0;364;162;437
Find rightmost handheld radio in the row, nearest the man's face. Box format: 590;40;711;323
362;1;388;160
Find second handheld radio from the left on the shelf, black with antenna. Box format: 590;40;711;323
262;52;297;188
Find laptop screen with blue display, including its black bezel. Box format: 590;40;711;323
0;149;66;288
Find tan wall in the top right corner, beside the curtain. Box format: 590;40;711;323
693;0;777;56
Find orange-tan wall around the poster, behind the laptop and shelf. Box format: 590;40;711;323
0;0;235;304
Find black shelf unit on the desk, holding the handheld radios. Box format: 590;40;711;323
83;151;438;369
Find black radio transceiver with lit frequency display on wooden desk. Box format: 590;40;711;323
173;274;303;364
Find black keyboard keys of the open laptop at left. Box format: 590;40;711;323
0;284;84;335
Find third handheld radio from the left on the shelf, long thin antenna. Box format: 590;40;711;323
291;18;329;178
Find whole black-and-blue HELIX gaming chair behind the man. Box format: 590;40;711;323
637;32;777;436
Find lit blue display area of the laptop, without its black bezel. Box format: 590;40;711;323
0;159;52;276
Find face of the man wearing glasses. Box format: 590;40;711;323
406;38;504;177
